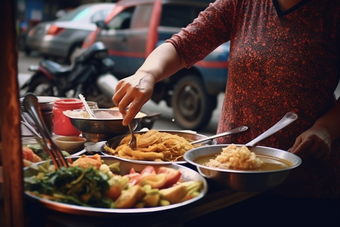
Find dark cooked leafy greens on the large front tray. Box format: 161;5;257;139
25;163;113;208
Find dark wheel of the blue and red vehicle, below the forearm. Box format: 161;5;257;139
171;75;217;130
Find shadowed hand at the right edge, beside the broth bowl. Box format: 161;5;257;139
288;126;332;160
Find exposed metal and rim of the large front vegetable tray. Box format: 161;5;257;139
24;156;208;216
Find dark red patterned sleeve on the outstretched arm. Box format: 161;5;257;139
166;0;235;68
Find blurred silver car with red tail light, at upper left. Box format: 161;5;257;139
25;3;115;63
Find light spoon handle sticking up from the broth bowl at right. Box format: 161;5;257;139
246;112;298;146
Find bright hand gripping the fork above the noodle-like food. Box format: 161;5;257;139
112;73;155;126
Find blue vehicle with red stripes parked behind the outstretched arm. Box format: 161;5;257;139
83;0;229;130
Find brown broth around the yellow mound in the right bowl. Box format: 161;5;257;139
194;154;293;171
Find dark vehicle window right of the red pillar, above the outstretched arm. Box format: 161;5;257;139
160;5;204;28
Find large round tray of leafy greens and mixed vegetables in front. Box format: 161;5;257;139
24;154;208;216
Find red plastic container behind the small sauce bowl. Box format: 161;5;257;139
53;99;84;136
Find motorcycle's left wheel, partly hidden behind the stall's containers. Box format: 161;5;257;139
27;75;58;96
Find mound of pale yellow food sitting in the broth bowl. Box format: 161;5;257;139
204;144;263;170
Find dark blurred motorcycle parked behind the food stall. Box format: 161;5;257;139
20;42;117;108
